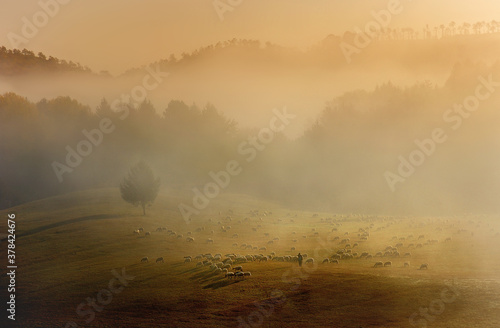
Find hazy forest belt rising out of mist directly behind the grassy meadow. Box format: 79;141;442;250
0;63;500;213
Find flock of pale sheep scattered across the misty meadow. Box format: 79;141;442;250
134;210;490;279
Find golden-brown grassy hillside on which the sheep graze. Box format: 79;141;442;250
0;189;500;328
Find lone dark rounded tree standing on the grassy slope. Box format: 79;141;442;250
120;161;160;215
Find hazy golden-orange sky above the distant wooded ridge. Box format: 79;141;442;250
0;0;500;74
